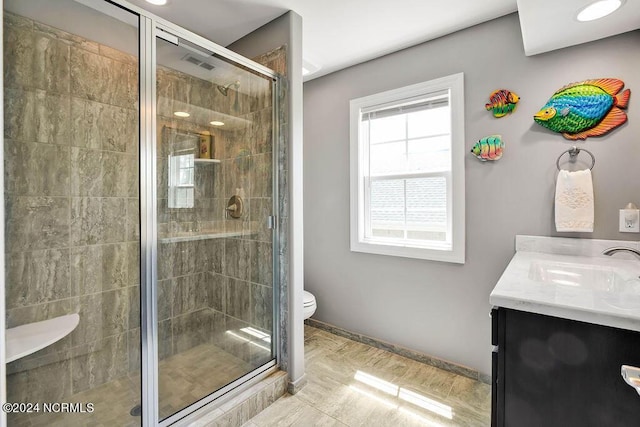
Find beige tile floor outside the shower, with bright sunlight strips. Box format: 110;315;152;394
244;326;491;427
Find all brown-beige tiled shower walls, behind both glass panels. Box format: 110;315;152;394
4;12;273;412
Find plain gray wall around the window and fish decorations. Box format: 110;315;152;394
304;14;640;373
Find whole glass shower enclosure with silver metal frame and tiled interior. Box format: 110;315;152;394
3;0;279;426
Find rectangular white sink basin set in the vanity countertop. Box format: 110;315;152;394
529;261;640;292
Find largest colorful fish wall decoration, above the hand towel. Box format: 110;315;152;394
533;79;631;140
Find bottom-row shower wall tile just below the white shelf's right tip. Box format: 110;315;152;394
71;333;129;393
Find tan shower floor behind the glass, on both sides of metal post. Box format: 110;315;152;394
9;344;253;427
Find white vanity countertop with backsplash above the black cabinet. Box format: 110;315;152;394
489;236;640;331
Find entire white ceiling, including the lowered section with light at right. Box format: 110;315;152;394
129;0;640;81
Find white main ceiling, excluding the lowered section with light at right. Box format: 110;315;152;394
129;0;516;80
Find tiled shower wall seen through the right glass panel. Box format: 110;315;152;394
157;61;273;366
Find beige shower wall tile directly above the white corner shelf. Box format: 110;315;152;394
6;249;72;309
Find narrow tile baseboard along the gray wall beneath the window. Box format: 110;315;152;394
304;318;491;384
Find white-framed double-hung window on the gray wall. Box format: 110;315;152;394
351;73;465;263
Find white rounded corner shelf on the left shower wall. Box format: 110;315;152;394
6;313;80;363
